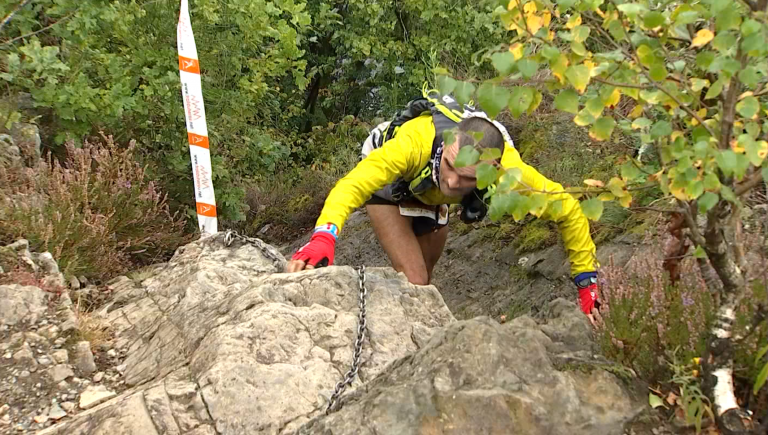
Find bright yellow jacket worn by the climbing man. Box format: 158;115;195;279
317;115;596;276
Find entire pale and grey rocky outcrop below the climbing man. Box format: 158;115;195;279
9;234;635;435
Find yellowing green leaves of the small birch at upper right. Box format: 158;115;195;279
436;0;768;242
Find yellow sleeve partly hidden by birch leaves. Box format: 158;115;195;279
501;146;597;277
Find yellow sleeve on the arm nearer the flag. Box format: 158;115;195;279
317;116;435;231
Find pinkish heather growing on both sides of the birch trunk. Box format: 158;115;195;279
600;228;768;414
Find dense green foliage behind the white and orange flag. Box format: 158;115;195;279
0;0;505;221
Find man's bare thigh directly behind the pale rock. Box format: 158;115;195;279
365;204;437;285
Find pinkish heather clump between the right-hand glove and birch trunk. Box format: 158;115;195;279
600;238;714;380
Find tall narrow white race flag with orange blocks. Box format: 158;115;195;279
176;0;218;234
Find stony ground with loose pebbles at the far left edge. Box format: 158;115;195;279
0;240;126;435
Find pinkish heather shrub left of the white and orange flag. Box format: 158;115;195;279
0;136;189;278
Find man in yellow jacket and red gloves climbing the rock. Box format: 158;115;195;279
288;91;599;324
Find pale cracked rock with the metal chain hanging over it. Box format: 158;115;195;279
44;234;454;435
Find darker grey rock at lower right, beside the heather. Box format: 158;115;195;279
296;299;642;435
